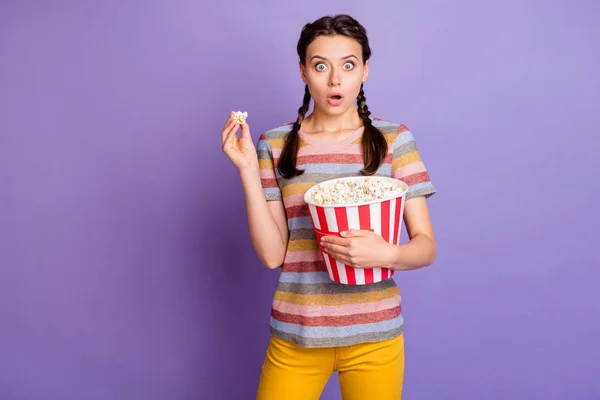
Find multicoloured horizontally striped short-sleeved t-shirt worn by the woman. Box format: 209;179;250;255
257;118;436;347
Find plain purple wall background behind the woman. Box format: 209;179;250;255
0;0;600;400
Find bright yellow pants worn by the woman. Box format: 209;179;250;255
256;335;404;400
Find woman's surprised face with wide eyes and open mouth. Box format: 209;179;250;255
300;35;369;115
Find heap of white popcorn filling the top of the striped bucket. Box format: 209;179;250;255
310;177;405;205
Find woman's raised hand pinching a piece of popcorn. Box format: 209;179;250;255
221;112;258;171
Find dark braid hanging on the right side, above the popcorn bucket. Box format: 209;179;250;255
357;84;388;175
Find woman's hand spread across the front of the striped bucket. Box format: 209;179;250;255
321;229;396;268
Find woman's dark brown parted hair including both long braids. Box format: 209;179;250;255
277;14;388;179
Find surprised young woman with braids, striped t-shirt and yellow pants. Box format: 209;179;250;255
222;15;436;400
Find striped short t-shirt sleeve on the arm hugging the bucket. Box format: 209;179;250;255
392;125;436;200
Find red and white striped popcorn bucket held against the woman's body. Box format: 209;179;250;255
304;176;408;285
